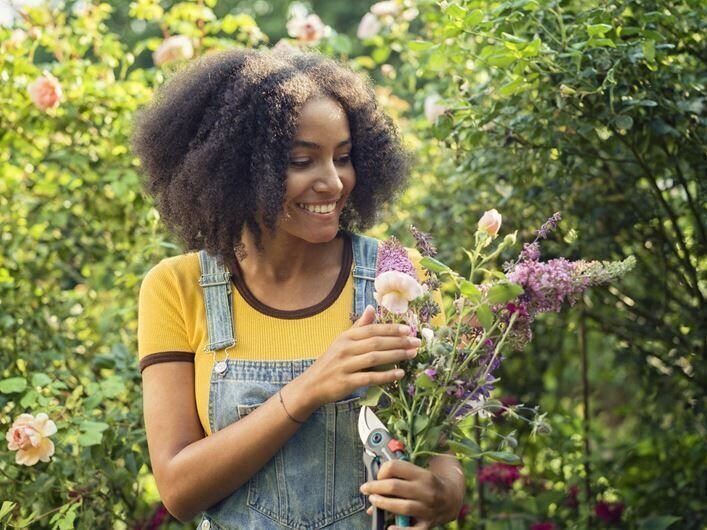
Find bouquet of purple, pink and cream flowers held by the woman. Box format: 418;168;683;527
362;210;635;465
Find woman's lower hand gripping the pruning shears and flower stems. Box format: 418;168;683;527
361;460;464;530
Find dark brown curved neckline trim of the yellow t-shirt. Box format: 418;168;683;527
231;232;353;320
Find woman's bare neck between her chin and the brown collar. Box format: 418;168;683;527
239;228;342;283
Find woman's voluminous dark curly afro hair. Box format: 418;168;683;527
132;49;413;262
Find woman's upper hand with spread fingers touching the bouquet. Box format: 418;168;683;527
302;306;420;407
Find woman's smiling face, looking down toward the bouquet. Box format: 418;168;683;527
278;97;356;243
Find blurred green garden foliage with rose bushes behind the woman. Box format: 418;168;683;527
0;0;707;530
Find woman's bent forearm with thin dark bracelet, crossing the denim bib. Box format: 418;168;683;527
158;372;316;521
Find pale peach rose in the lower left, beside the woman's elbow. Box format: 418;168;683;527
5;412;56;466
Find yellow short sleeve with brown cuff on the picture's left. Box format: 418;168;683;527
137;262;194;371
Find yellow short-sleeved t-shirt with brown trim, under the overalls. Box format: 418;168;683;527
138;237;444;435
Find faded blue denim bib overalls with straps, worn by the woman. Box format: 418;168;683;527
198;234;378;530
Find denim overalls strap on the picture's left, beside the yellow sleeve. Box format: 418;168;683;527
199;250;236;351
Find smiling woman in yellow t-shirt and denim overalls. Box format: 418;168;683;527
134;50;465;529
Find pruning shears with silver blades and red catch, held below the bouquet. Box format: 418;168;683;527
358;406;412;530
